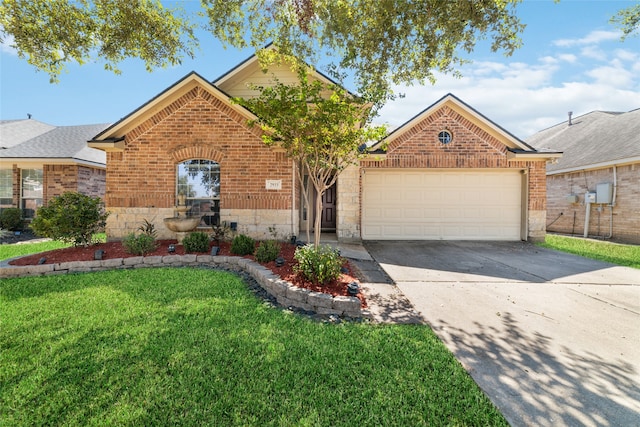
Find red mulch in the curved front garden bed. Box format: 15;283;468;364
9;240;367;308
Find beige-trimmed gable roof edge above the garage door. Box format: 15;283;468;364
371;93;562;159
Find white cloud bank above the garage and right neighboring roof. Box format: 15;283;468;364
379;43;640;139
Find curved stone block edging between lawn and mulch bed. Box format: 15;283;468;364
0;254;363;318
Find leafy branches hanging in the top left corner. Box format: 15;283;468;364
0;0;197;82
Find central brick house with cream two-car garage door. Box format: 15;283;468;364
89;51;560;240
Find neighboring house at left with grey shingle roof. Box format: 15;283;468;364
0;119;108;219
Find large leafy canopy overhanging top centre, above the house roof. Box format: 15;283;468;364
202;0;524;105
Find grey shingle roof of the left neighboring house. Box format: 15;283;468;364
0;120;108;167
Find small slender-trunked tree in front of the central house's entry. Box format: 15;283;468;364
234;58;385;247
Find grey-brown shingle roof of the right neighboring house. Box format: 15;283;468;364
527;108;640;174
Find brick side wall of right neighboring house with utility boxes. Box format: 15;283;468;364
547;163;640;244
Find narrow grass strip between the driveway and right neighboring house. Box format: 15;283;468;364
539;234;640;269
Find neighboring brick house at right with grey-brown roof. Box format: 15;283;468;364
527;109;640;244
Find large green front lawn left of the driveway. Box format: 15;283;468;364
0;268;507;426
